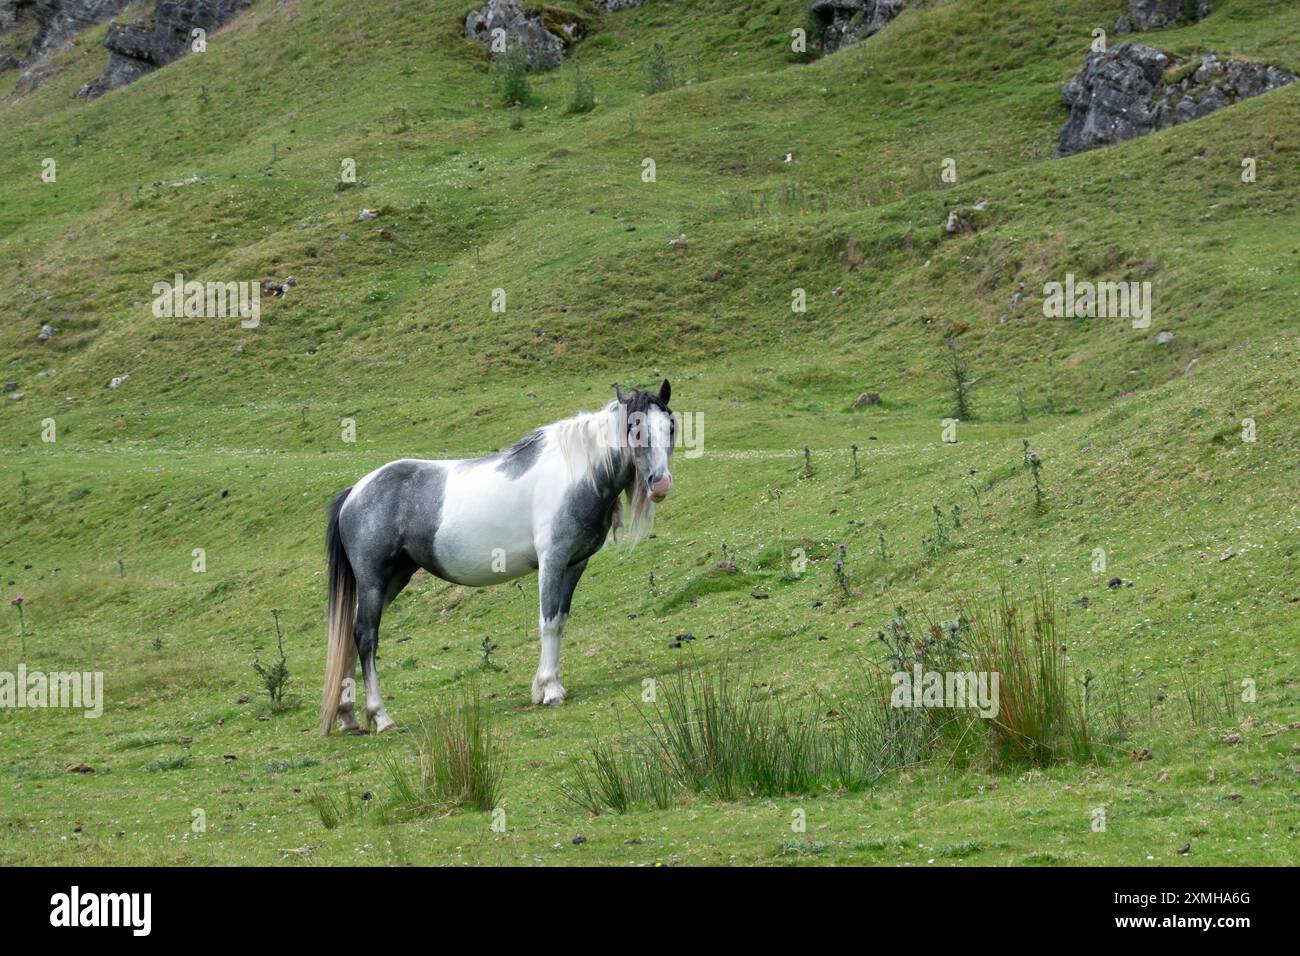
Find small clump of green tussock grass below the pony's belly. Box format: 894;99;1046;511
385;692;507;817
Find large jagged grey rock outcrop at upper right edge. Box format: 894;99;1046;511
1057;43;1295;156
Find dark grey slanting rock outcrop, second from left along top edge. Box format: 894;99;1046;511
77;0;252;99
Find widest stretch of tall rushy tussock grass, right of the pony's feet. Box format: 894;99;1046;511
560;587;1127;814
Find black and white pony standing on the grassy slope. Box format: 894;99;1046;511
321;380;676;734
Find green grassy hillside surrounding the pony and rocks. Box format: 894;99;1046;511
0;0;1300;865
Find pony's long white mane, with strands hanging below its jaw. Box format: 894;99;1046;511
541;393;654;550
